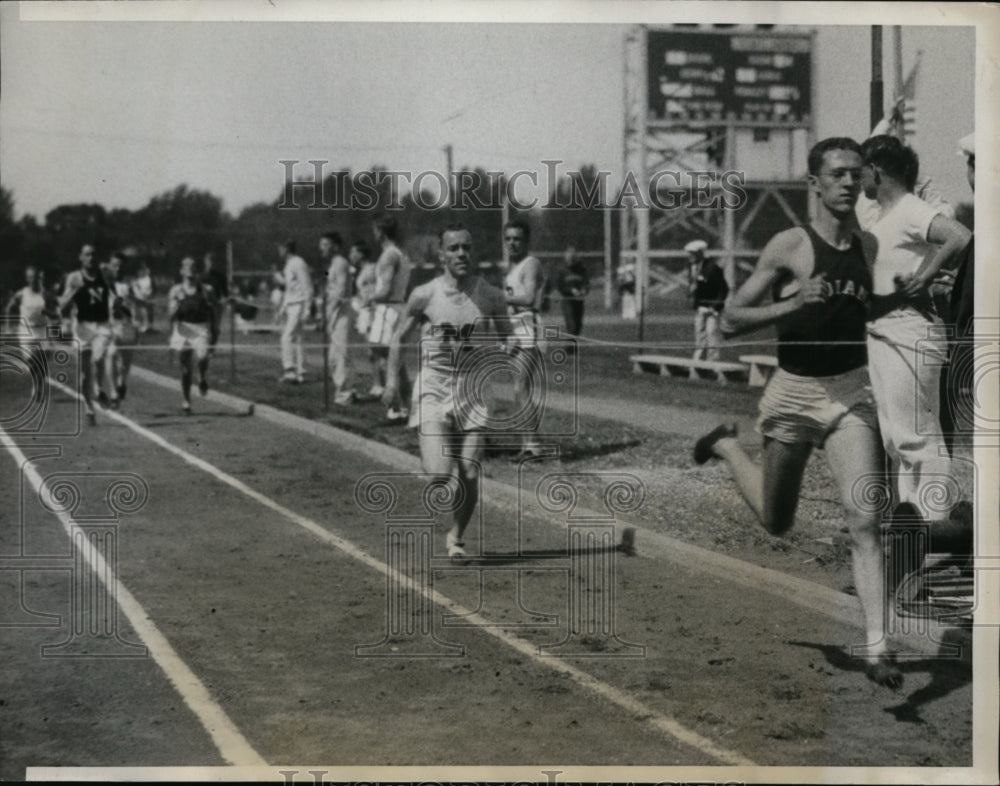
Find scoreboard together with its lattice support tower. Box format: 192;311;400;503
620;25;815;326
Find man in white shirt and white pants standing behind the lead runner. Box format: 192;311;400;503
861;135;970;524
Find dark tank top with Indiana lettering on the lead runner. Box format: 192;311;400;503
774;226;872;377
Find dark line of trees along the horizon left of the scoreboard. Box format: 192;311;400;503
0;166;616;291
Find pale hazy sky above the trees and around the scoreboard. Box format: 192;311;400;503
0;3;975;217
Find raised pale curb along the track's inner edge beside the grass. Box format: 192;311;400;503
131;366;948;655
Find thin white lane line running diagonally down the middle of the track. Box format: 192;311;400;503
60;382;756;767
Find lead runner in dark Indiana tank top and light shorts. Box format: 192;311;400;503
693;137;903;689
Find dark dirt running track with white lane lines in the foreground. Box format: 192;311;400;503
0;364;972;779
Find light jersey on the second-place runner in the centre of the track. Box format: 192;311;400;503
409;276;507;375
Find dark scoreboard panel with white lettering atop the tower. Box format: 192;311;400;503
647;30;812;125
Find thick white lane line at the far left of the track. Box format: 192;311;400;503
0;426;267;767
